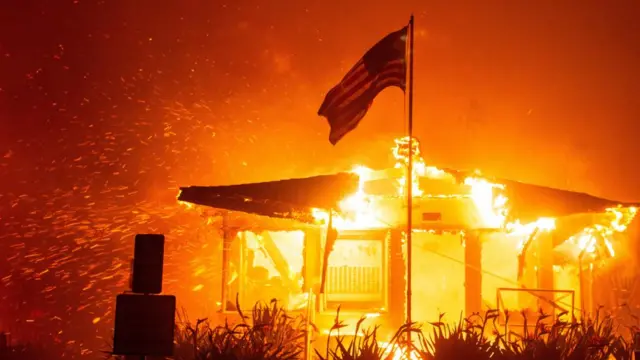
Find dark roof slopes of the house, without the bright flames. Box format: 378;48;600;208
178;169;640;223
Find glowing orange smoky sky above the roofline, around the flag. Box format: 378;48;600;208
0;0;640;200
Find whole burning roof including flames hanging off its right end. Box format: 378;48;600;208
178;138;639;256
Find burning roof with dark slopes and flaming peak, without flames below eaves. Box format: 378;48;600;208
178;138;638;223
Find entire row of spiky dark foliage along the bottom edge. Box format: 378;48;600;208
170;301;632;360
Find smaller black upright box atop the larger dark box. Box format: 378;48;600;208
131;234;164;294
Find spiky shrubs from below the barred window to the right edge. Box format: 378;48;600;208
318;310;632;360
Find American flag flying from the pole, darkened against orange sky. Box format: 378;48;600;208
318;26;408;145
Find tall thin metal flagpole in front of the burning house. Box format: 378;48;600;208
407;14;413;359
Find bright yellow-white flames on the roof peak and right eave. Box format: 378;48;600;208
312;137;637;262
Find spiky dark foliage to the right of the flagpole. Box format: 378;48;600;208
415;310;631;360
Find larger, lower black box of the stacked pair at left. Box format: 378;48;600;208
113;294;176;356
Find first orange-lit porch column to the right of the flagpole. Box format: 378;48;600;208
464;231;482;316
